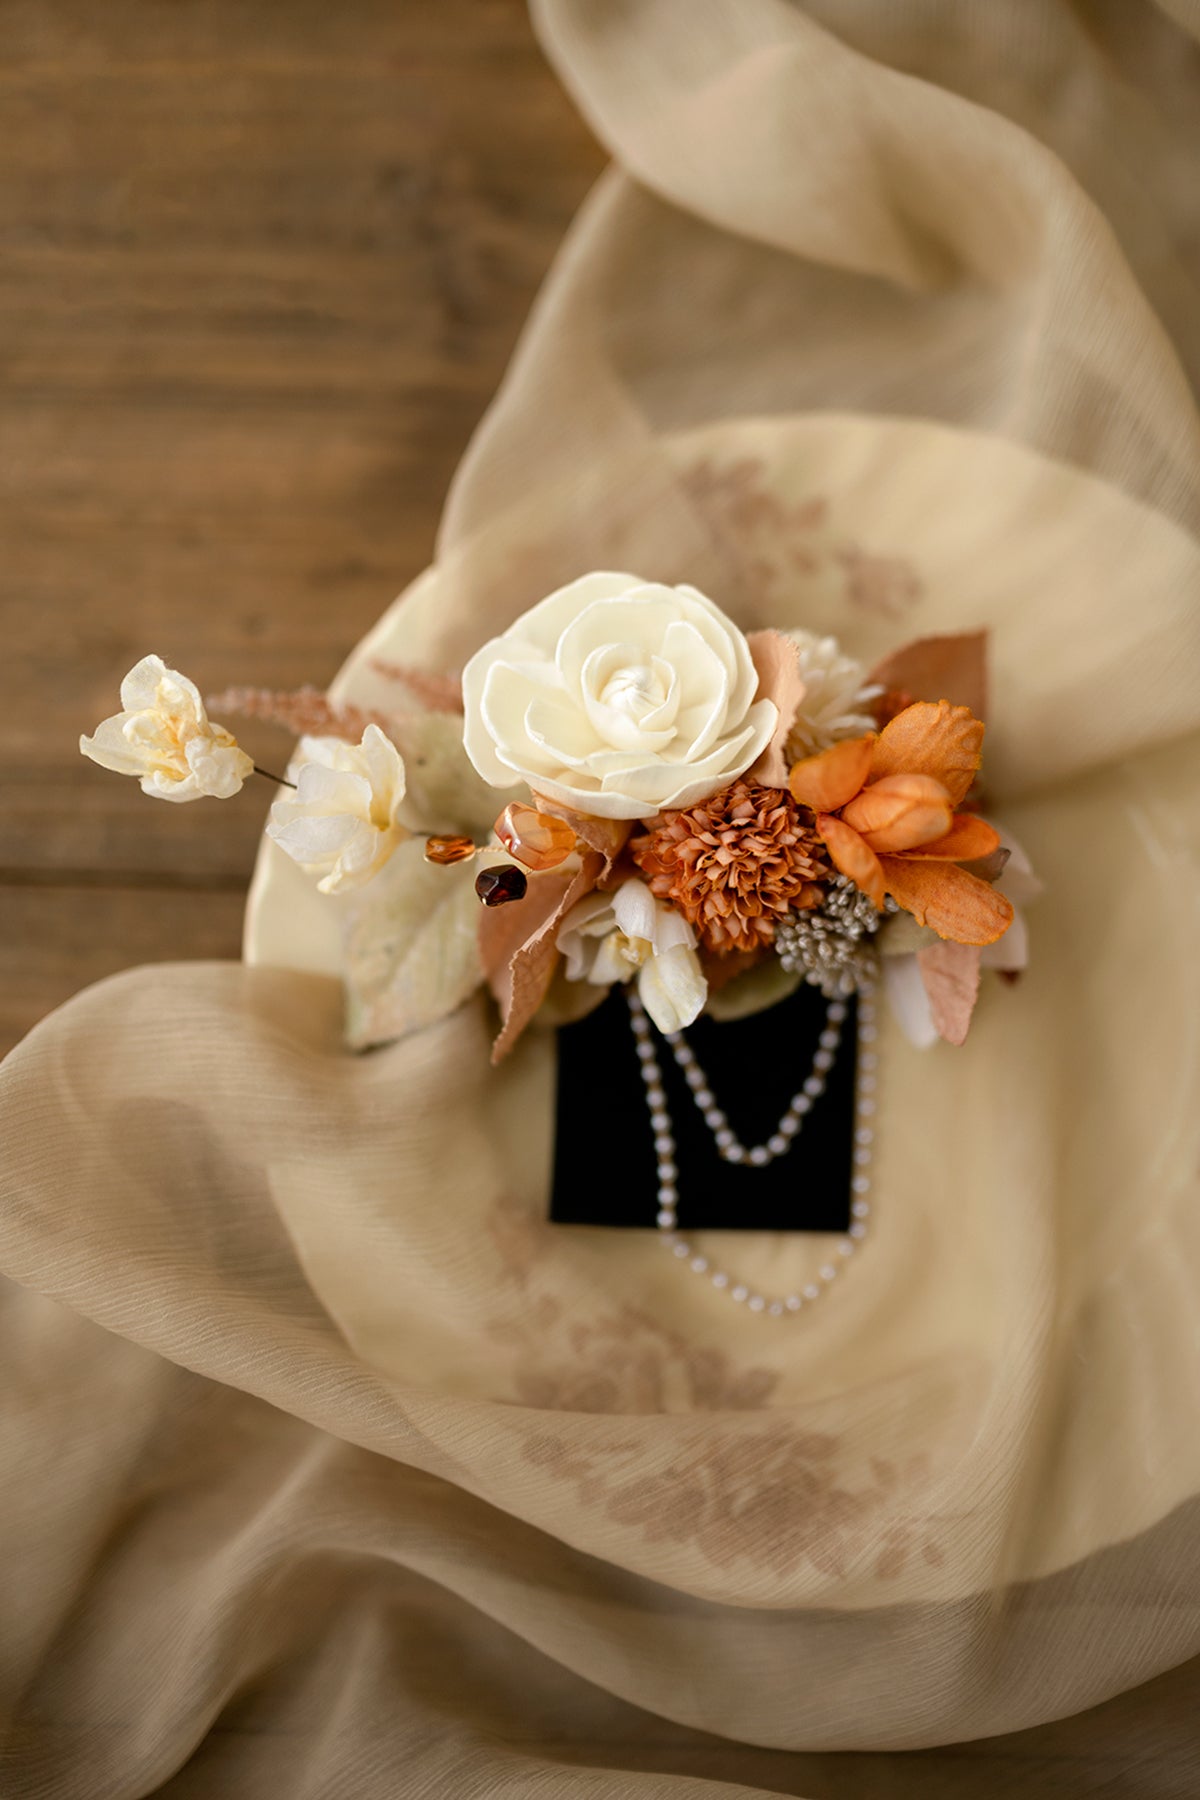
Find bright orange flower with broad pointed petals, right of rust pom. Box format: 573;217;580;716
788;700;1013;943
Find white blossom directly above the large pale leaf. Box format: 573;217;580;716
266;725;412;895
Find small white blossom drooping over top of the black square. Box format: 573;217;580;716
556;877;709;1031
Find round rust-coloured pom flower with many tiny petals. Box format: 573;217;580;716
630;779;831;952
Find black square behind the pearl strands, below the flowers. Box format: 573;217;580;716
551;986;858;1231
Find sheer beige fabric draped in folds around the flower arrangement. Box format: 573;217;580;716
0;0;1200;1800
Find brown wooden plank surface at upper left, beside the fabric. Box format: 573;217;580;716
0;0;603;1051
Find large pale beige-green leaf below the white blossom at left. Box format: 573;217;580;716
345;841;484;1049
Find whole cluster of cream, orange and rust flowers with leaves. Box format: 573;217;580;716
81;572;1036;1058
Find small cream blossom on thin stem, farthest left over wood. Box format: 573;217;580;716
79;657;254;801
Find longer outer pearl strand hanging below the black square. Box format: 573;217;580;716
626;983;878;1318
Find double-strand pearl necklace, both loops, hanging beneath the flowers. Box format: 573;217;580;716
626;983;878;1318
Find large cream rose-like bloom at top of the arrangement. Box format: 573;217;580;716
462;574;777;819
